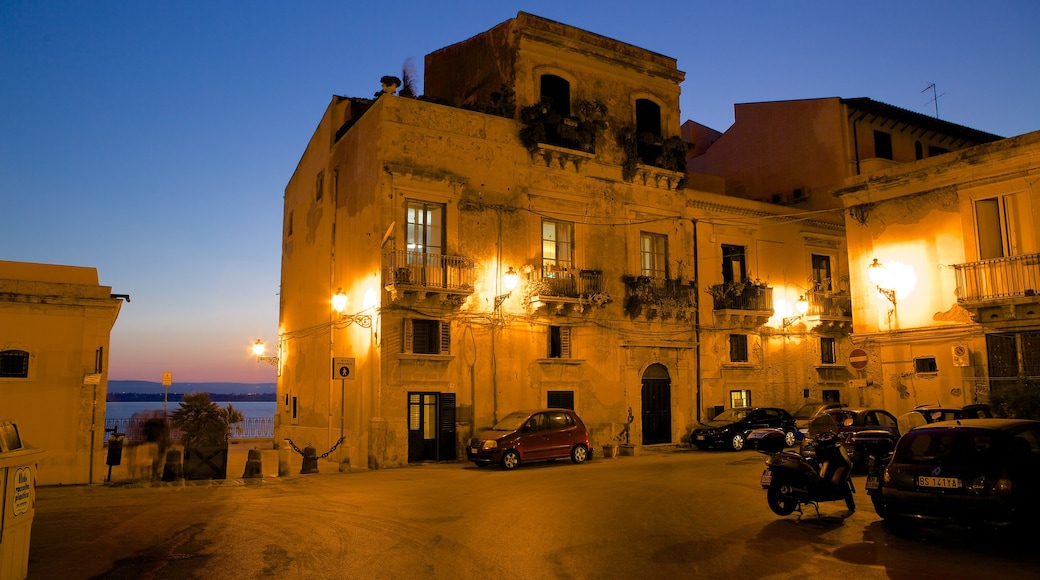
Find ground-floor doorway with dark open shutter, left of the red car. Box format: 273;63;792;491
408;393;457;463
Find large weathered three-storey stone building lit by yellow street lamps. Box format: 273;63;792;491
276;12;851;469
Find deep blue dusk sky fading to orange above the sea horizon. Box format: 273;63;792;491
0;0;1040;384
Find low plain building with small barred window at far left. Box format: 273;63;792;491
0;261;123;485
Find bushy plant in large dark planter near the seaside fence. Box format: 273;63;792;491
170;393;245;479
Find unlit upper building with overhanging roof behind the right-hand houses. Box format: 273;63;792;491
683;97;1000;210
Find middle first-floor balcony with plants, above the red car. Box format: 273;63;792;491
527;267;612;314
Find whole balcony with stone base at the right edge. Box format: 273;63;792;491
954;254;1040;324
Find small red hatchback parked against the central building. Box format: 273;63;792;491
466;408;592;469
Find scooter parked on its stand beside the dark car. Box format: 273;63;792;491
756;431;856;516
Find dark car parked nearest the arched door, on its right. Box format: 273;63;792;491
690;406;797;451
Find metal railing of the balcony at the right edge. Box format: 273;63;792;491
954;254;1040;302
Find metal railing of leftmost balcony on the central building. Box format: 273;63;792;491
383;249;475;290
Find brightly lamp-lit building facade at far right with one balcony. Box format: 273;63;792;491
836;132;1040;413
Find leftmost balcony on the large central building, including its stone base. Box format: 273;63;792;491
383;249;475;307
